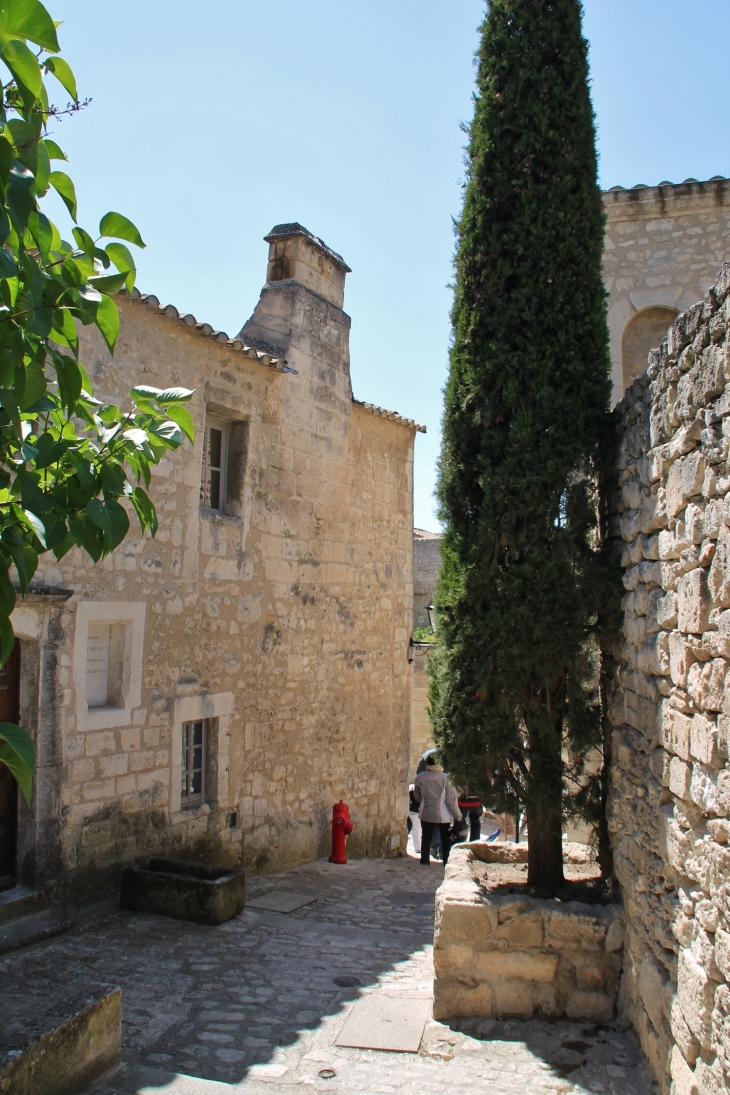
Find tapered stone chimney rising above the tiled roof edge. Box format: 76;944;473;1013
239;222;351;385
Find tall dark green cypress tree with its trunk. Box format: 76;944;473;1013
430;0;610;892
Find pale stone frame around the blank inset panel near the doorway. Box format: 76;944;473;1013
73;601;147;731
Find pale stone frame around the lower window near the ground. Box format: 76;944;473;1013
170;692;233;821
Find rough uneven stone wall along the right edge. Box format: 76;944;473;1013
610;265;730;1095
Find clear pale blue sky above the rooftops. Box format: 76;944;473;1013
46;0;730;529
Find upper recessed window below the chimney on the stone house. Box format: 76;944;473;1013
200;415;248;517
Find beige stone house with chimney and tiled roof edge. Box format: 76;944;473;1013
0;224;422;892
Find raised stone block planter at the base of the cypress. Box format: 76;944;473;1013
433;844;624;1023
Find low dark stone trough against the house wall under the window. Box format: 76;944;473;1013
121;857;245;924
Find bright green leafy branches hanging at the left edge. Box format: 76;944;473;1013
0;0;194;802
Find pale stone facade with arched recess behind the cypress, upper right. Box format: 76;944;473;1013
603;176;730;403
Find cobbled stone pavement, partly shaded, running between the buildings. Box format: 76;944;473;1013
0;857;651;1095
